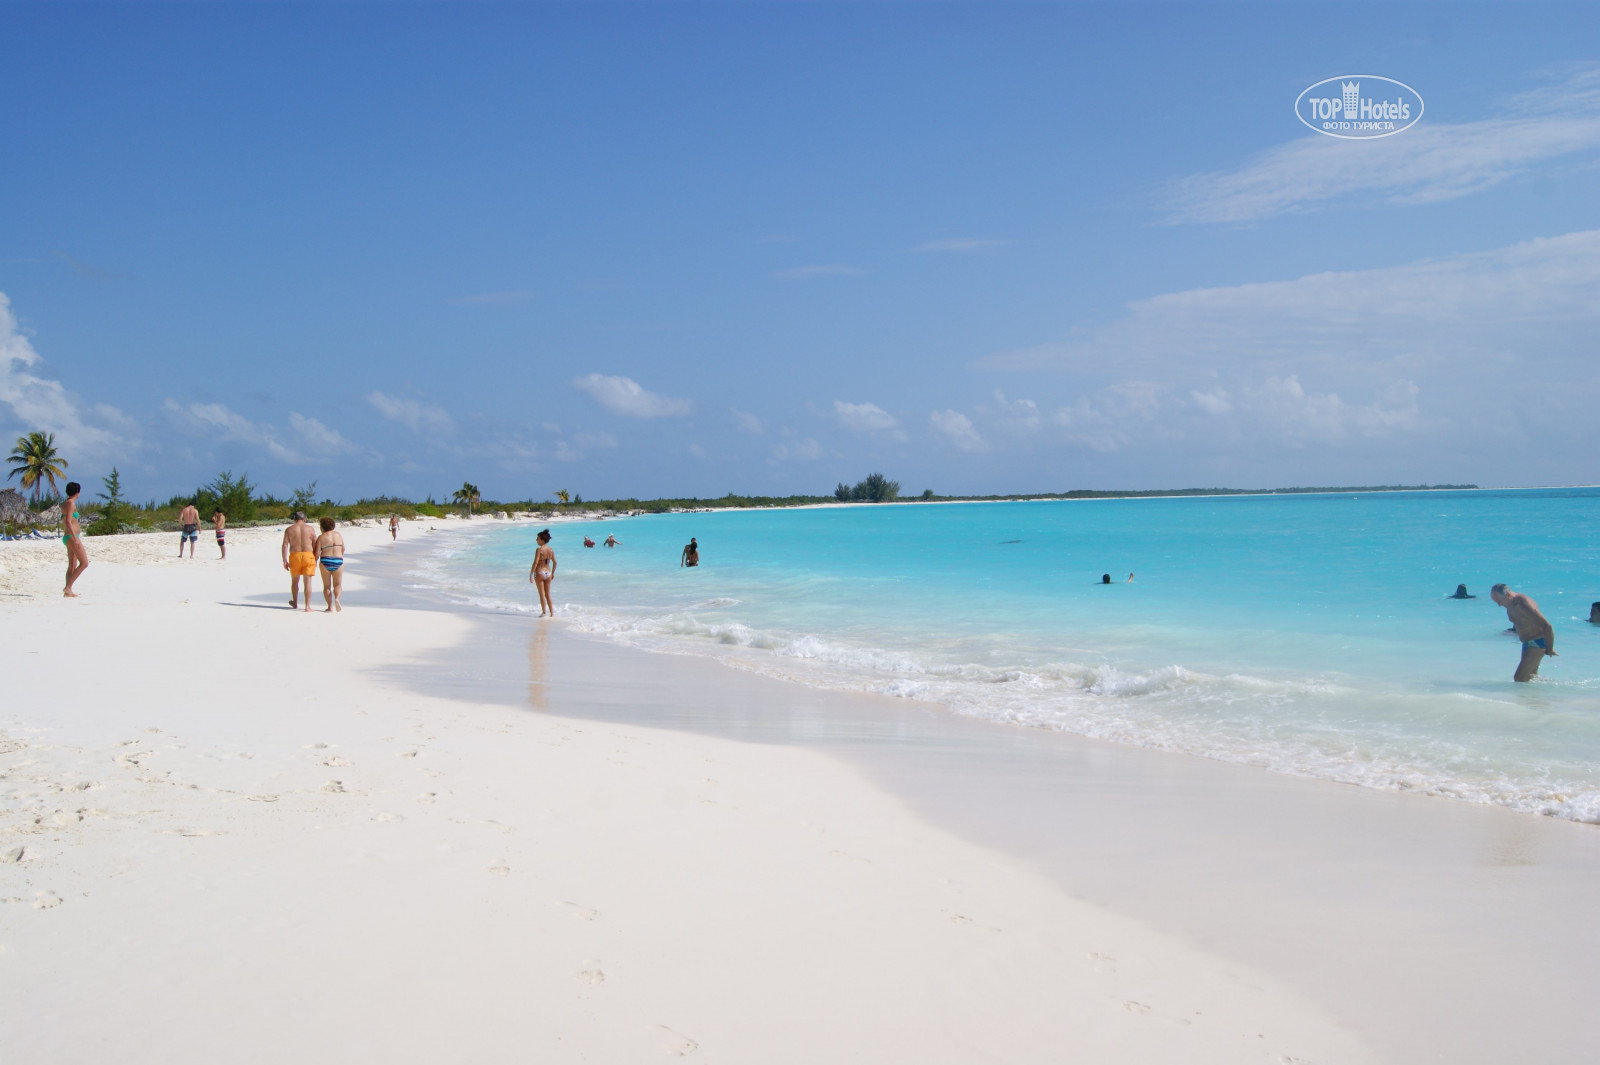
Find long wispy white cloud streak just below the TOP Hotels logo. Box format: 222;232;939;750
1162;66;1600;222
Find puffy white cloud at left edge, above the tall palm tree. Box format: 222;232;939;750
0;293;138;469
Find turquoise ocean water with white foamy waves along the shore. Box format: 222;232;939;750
413;489;1600;822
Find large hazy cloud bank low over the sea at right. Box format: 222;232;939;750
978;230;1600;460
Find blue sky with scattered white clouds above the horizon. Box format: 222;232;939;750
0;2;1600;502
